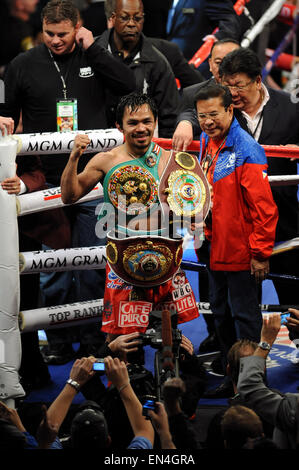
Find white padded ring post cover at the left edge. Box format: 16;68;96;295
0;131;25;401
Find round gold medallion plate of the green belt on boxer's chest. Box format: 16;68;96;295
107;164;158;215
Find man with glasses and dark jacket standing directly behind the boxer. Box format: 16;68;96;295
96;0;179;137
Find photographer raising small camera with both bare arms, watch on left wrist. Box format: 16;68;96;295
27;356;154;449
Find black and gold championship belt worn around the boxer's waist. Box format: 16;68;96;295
106;231;183;287
